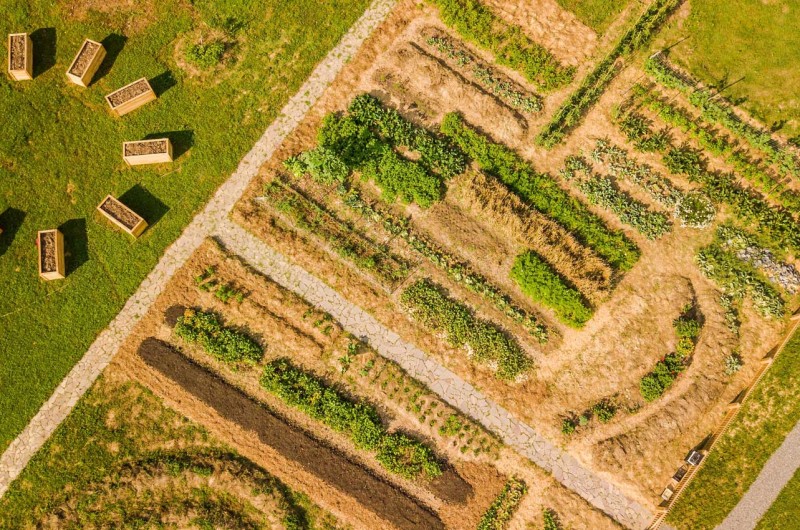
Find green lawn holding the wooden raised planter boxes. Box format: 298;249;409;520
0;0;369;451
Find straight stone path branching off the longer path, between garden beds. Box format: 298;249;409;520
216;220;653;529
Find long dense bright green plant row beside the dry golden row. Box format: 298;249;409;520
442;113;640;271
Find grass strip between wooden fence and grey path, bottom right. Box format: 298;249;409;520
667;324;800;530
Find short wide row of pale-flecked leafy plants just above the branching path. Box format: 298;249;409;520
400;279;533;380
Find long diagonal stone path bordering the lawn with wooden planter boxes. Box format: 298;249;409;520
0;0;395;496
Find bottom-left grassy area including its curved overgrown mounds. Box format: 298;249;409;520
0;377;338;530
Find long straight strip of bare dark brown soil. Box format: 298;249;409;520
138;338;444;530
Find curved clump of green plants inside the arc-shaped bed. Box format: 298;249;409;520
639;304;702;402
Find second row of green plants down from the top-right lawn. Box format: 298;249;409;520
633;84;800;213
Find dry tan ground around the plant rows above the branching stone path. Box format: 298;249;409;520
225;0;782;505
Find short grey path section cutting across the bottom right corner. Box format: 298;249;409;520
717;423;800;530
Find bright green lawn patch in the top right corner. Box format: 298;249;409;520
672;0;800;137
